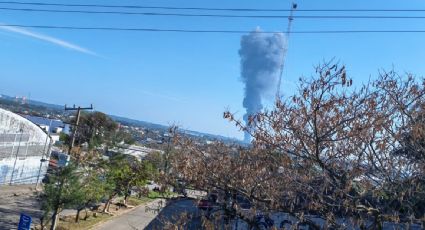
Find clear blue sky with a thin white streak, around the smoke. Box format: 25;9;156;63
0;0;425;138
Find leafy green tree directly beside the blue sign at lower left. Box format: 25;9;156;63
42;164;84;230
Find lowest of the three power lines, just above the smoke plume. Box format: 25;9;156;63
0;24;425;34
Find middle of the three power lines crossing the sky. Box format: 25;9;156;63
0;7;425;19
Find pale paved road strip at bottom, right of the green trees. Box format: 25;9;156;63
94;200;165;230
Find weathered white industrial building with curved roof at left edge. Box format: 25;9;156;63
0;109;52;185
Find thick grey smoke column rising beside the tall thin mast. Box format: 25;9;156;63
239;29;284;142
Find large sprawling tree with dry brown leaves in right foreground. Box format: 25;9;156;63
164;63;425;229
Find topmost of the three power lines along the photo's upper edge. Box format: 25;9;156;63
0;1;425;12
